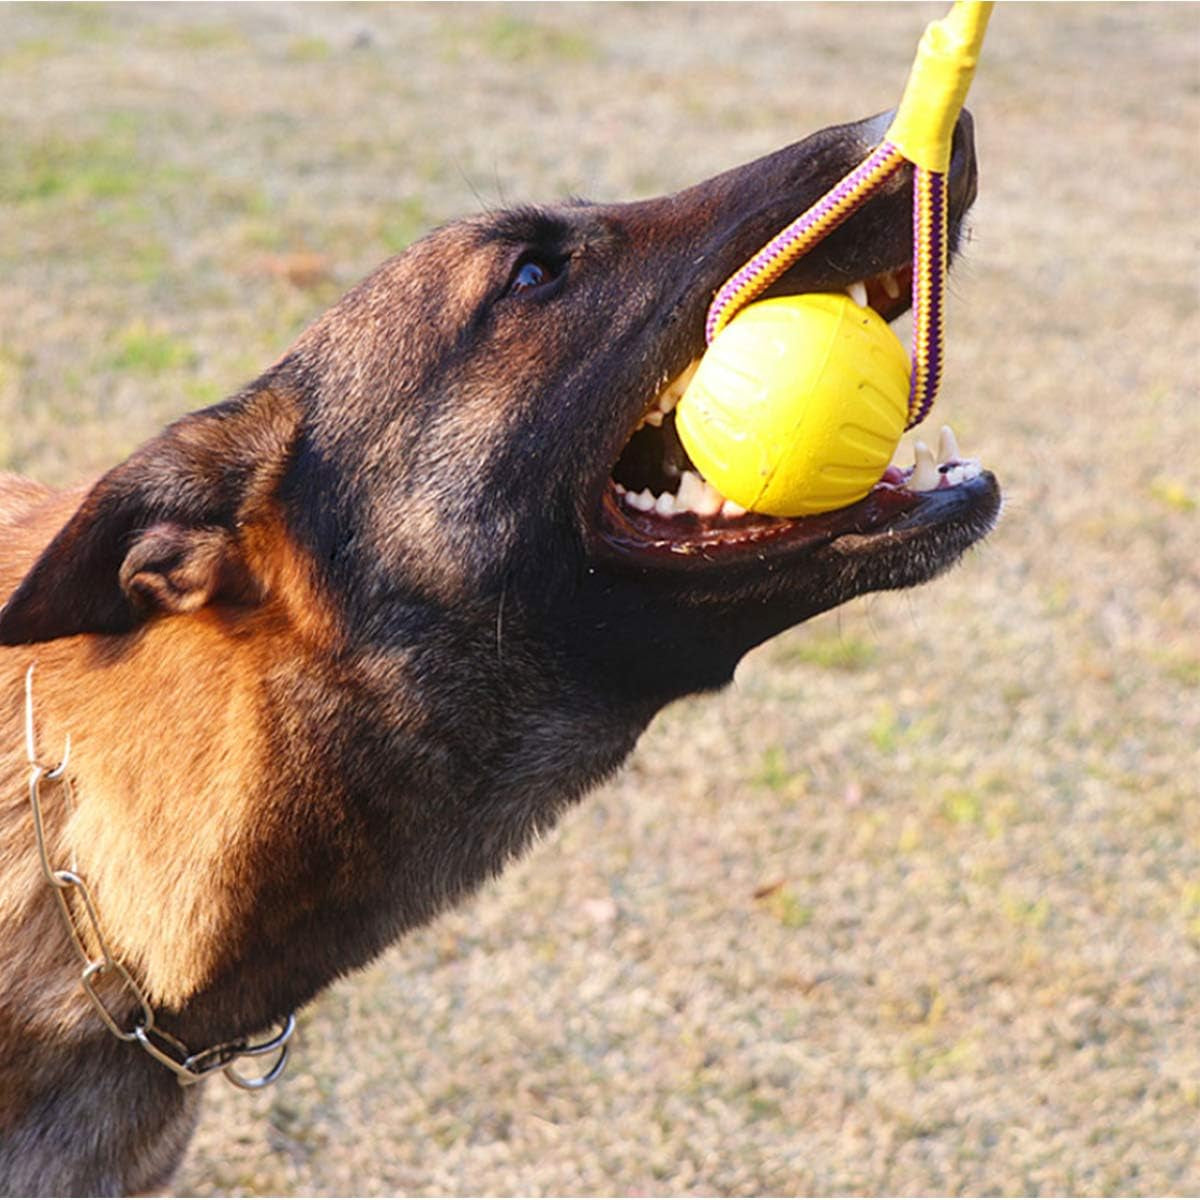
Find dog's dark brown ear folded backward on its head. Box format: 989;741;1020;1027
0;386;300;646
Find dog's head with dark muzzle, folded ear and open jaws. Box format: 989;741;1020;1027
0;109;1000;704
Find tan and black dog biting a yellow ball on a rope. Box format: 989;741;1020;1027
0;105;1000;1194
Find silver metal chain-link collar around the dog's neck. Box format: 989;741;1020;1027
25;666;296;1091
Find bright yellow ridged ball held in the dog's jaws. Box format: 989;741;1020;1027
676;293;908;517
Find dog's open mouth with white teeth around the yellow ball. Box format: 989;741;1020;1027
600;266;990;565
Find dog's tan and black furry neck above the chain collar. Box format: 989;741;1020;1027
0;595;642;1046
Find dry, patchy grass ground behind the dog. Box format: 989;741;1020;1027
0;4;1200;1195
